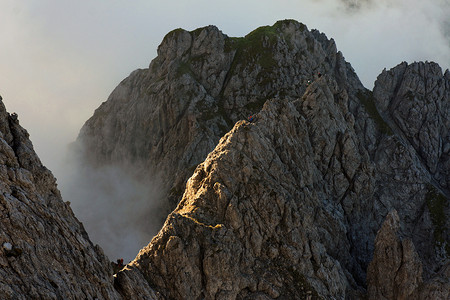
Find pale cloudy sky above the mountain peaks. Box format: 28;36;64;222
0;0;450;188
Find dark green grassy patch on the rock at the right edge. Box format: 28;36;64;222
425;184;450;256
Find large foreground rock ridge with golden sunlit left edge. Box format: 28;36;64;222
111;62;449;299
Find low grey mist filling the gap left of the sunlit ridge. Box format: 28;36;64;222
58;145;168;262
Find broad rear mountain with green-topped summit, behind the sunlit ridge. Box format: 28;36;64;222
78;20;365;208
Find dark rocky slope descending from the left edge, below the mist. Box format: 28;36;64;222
0;97;130;300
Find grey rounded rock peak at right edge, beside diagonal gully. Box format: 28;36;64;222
374;62;450;192
